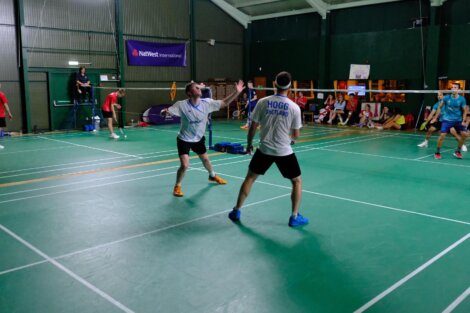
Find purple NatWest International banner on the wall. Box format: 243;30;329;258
126;40;186;66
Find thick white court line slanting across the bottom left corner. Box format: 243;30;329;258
0;224;134;313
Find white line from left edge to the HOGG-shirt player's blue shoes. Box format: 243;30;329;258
0;192;291;276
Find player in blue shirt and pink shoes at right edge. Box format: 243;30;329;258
434;83;468;160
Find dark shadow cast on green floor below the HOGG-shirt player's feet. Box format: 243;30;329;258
224;223;366;312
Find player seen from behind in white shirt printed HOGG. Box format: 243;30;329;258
229;72;308;227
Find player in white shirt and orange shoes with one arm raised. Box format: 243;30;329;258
162;80;244;197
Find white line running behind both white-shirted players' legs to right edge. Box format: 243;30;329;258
195;168;470;225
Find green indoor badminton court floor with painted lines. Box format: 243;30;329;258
0;121;470;313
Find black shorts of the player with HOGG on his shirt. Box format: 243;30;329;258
249;149;301;179
